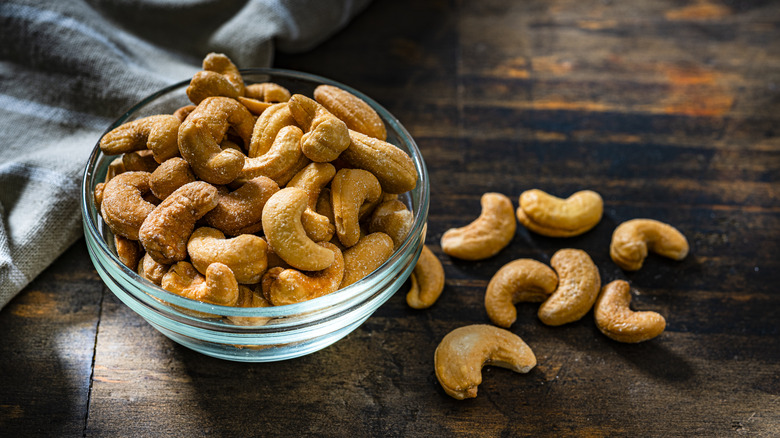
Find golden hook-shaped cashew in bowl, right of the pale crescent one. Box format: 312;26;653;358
330;169;382;247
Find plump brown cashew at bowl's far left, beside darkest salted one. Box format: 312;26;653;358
100;172;155;240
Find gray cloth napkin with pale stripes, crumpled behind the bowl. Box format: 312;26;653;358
0;0;370;308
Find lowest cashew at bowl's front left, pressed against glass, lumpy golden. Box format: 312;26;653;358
161;261;238;306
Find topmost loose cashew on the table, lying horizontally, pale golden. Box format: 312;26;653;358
517;189;604;237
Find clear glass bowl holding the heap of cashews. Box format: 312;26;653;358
81;69;429;362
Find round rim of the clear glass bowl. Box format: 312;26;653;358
80;68;430;318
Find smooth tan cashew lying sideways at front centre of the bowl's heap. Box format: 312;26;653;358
187;227;268;284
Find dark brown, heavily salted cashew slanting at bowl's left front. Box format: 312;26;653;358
138;181;218;264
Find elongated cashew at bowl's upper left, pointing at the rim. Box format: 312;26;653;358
100;114;181;163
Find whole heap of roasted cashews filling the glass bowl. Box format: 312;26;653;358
94;53;426;325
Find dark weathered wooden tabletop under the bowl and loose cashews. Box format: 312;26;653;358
0;0;780;437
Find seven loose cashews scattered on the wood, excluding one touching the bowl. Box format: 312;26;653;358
426;189;689;400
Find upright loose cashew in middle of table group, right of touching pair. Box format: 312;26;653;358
537;249;601;326
